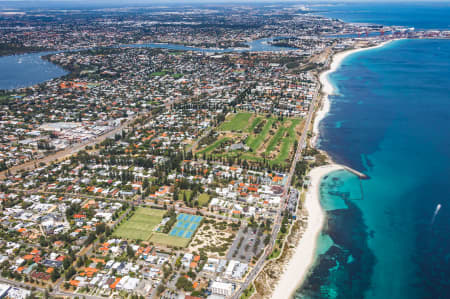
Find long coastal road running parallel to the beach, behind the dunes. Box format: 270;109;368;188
231;75;320;299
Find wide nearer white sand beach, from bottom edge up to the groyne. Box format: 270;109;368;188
272;164;343;299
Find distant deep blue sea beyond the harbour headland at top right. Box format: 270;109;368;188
311;0;450;30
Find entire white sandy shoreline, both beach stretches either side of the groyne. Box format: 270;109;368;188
271;40;393;299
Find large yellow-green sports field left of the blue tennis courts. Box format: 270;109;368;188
113;207;166;240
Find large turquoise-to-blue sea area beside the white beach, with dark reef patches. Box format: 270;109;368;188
297;40;450;299
